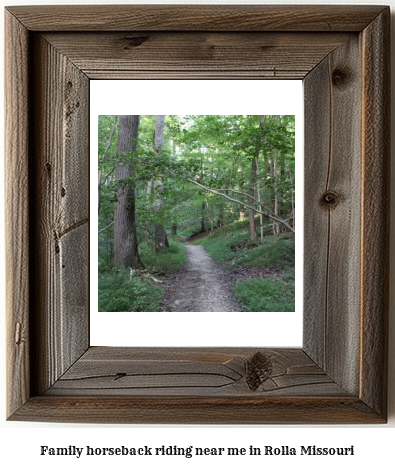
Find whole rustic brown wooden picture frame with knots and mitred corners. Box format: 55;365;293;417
5;5;390;424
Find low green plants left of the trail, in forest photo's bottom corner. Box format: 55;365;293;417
99;269;164;312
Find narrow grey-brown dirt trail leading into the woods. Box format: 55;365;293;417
164;243;241;312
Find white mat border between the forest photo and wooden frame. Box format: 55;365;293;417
90;80;303;347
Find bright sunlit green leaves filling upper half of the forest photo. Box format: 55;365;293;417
98;115;295;238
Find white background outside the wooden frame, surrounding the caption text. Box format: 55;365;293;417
0;0;395;469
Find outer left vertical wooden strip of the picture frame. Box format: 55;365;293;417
5;12;30;413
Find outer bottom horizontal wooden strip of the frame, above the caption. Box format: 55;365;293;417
11;395;384;425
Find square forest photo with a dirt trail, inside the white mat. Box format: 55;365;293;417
98;115;295;312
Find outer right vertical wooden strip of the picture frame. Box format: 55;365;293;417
360;8;391;415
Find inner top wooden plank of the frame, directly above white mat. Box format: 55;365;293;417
44;32;349;79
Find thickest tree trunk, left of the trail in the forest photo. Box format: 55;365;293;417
114;116;144;269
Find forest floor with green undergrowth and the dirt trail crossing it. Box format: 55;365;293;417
98;221;295;312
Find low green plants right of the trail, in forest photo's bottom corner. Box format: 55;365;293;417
234;276;295;312
